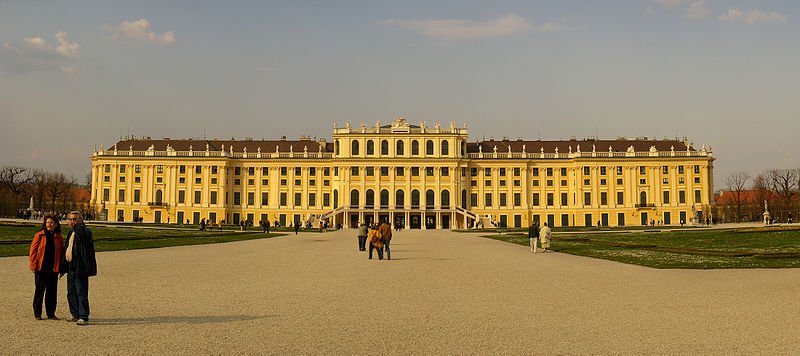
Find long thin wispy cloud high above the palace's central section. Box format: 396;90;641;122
380;14;536;41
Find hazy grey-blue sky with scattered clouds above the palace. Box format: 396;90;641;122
0;0;800;189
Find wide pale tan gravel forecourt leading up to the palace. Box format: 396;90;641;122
0;230;800;354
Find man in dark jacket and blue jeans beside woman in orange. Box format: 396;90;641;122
61;211;97;325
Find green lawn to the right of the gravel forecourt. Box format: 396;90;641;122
482;226;800;269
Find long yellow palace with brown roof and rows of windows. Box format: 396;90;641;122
90;118;714;229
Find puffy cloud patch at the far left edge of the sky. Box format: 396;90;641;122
0;31;81;76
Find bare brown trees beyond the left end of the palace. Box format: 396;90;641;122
0;166;82;216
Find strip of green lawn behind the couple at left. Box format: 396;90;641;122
0;223;283;257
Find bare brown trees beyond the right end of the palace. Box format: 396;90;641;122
717;168;800;222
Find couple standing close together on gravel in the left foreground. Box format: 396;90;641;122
28;211;97;325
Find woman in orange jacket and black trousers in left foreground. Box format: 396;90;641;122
28;215;64;320
